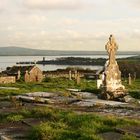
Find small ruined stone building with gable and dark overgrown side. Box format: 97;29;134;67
3;65;43;82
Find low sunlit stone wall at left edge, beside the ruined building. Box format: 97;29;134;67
0;76;16;84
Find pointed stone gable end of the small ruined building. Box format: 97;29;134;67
24;66;44;82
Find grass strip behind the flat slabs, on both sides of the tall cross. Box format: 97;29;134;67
0;78;140;99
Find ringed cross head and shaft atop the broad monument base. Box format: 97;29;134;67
105;35;118;64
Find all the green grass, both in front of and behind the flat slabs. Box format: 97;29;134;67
0;78;140;140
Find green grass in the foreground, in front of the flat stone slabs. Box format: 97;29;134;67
0;107;140;140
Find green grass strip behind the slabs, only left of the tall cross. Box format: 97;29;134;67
0;78;96;96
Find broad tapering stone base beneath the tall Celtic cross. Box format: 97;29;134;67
101;61;127;100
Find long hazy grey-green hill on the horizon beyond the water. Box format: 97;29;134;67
0;46;140;56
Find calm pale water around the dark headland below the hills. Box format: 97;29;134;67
0;55;137;71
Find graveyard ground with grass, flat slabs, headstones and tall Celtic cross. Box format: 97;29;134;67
0;35;140;140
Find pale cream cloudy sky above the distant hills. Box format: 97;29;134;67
0;0;140;51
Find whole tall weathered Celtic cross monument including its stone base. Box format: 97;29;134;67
101;35;126;100
